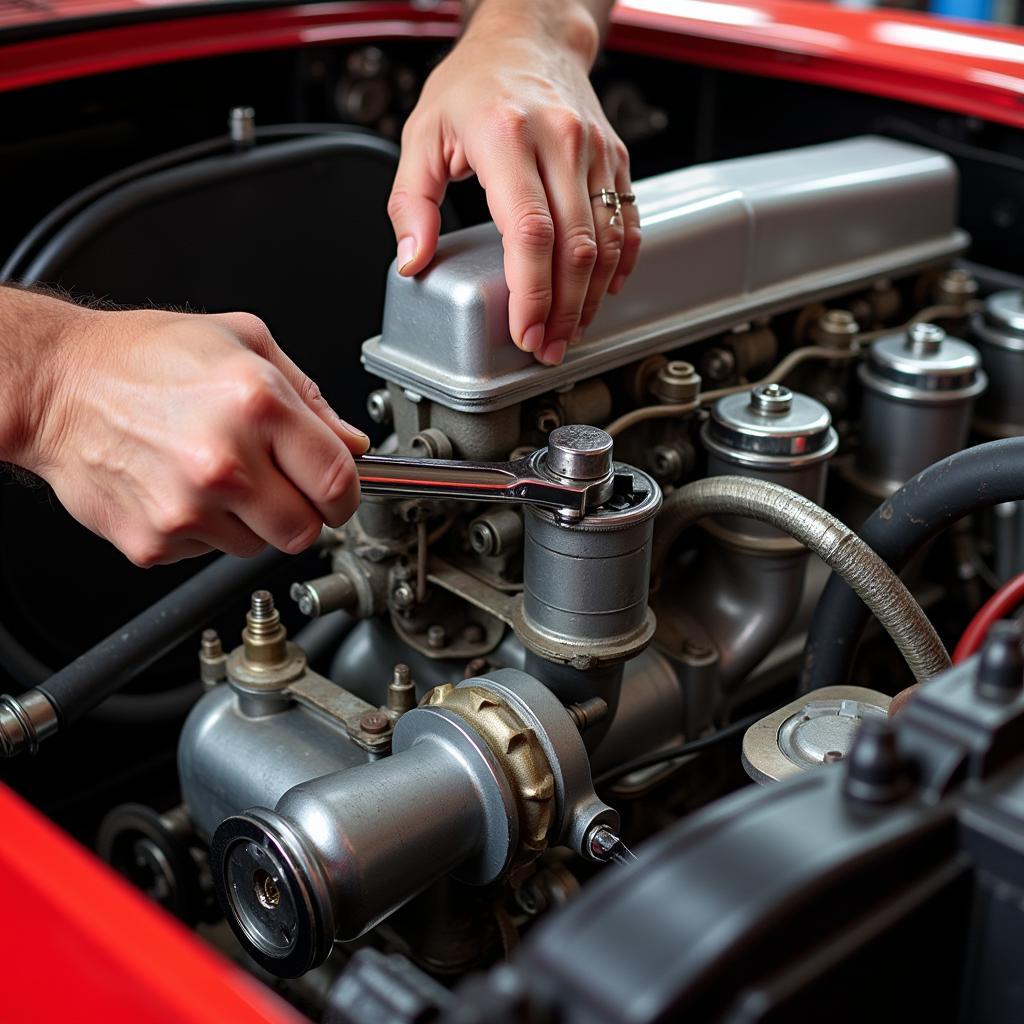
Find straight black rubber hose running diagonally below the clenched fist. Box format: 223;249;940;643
39;548;292;727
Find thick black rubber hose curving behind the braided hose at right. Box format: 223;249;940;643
800;437;1024;693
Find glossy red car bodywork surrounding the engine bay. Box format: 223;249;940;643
0;0;1024;1024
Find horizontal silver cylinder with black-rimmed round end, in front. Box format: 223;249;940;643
211;737;487;977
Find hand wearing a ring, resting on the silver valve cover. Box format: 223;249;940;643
388;0;640;364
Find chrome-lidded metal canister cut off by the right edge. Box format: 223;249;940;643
971;291;1024;437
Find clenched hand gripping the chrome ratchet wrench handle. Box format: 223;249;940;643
22;305;369;566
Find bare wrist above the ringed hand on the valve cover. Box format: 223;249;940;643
466;0;601;71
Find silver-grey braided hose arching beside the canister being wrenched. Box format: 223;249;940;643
651;476;949;681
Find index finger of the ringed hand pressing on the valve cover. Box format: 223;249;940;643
476;137;555;353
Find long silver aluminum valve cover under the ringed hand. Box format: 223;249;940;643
362;136;968;413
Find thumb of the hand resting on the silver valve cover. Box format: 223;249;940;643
387;129;449;278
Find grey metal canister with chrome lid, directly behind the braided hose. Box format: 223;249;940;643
701;384;839;542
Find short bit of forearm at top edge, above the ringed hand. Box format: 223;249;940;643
463;0;614;68
